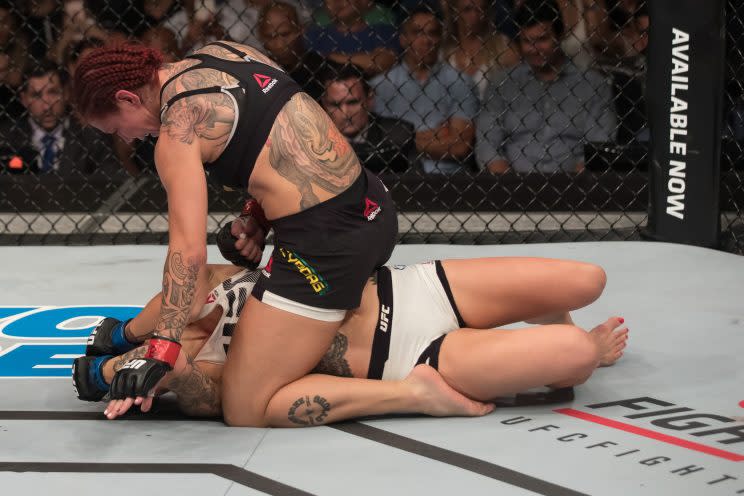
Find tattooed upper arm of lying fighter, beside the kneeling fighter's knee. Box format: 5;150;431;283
168;357;222;417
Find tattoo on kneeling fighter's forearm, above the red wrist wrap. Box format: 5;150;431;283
155;251;200;341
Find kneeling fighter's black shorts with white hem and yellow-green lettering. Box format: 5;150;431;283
252;169;398;320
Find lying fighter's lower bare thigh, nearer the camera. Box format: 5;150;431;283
439;325;598;399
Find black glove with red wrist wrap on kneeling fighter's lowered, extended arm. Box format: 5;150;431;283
110;336;181;400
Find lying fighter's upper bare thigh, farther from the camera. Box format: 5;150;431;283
442;257;606;329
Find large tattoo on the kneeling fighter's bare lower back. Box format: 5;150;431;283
269;93;361;209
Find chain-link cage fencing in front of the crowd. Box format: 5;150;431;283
0;0;744;253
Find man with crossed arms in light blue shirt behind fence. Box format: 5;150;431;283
371;9;478;173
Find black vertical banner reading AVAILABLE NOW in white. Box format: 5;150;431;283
644;0;726;248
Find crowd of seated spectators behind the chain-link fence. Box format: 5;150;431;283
0;0;649;175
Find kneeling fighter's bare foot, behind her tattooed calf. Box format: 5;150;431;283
404;364;494;417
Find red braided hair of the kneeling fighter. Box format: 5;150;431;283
72;43;163;118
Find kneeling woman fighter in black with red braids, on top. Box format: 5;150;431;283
73;42;406;426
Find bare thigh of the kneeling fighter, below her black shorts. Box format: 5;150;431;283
222;297;340;425
